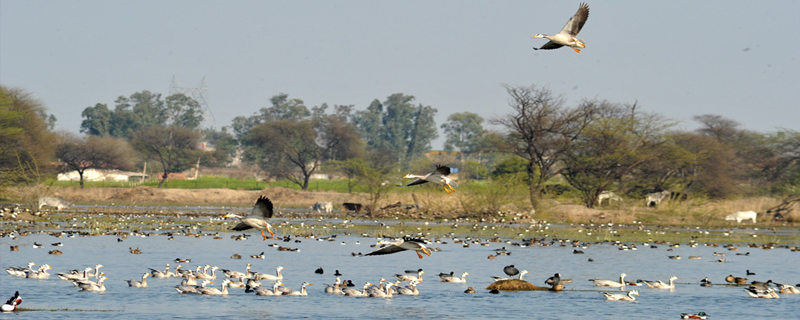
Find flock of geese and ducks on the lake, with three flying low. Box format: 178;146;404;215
2;165;800;319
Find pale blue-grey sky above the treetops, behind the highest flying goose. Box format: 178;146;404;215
0;0;800;149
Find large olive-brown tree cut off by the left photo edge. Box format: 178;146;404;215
0;86;55;185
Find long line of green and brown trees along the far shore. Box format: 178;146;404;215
0;85;800;211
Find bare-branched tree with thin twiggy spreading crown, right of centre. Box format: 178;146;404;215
492;86;596;208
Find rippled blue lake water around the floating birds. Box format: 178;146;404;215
0;211;800;319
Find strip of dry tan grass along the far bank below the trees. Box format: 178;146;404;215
4;185;800;226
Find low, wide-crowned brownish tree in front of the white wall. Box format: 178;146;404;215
56;135;135;188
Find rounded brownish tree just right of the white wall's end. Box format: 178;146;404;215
132;125;201;188
